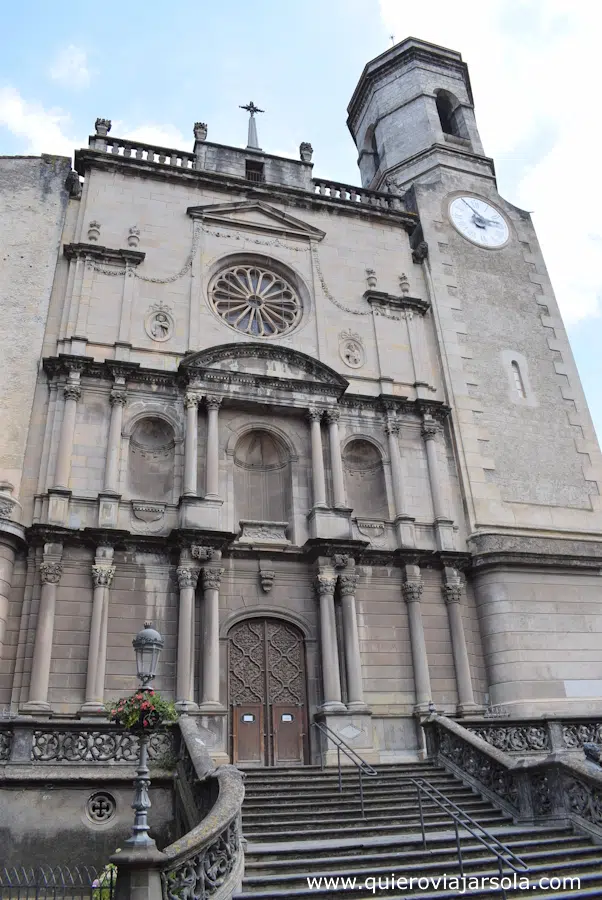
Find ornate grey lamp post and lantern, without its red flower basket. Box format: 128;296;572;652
125;622;165;848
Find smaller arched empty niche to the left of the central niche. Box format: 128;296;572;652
128;416;176;503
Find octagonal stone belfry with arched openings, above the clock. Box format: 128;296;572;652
347;38;494;190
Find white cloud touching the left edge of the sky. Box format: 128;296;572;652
0;87;81;157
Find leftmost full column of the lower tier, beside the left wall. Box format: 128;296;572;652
24;544;63;712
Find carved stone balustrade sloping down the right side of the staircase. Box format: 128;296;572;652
422;715;602;843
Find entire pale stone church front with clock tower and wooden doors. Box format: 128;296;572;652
0;39;602;765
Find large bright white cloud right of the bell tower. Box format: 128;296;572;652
379;0;602;322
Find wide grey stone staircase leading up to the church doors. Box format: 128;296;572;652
238;762;602;900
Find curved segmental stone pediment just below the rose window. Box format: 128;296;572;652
180;342;349;393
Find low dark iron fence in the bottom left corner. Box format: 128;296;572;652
0;866;117;900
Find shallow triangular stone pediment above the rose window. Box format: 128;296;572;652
187;200;325;241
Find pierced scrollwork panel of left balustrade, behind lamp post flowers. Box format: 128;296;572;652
31;729;174;764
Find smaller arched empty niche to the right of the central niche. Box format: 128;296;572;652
343;438;389;519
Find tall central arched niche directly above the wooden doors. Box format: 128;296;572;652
234;428;291;522
